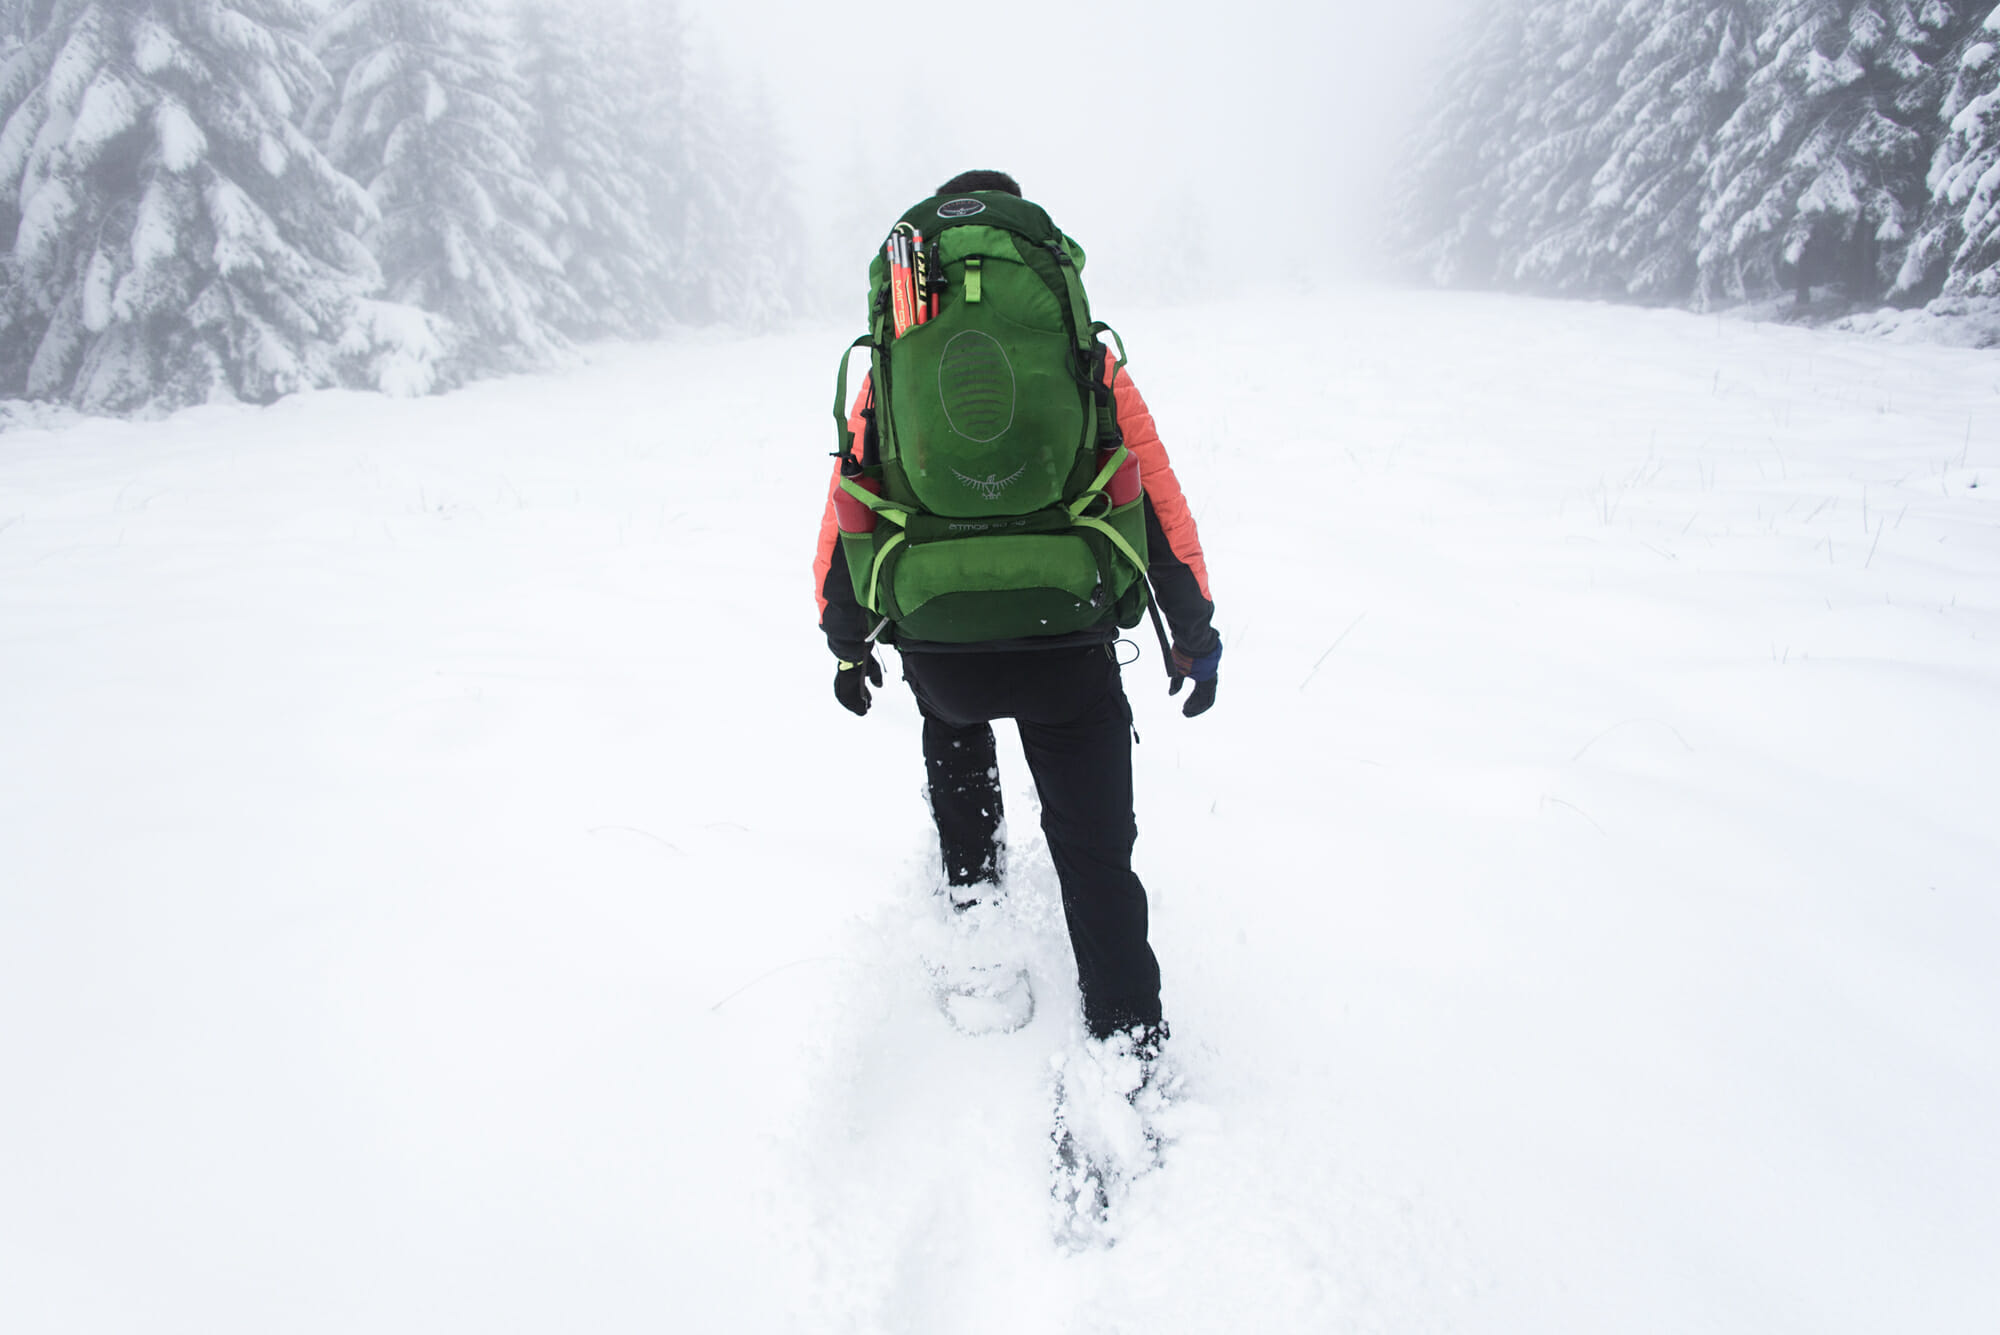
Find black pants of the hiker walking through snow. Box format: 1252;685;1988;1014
902;646;1160;1037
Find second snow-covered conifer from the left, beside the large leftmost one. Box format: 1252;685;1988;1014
316;0;576;382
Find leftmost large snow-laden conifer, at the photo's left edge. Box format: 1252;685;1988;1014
0;0;374;412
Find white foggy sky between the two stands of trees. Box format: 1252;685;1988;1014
684;0;1468;307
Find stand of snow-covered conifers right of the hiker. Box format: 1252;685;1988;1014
1394;0;2000;317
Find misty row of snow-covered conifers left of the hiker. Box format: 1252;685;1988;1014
0;0;796;412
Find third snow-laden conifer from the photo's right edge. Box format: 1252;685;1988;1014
1586;0;1756;302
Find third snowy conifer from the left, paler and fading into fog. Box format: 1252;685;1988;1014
520;0;668;338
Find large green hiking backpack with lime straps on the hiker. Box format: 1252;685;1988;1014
834;190;1146;644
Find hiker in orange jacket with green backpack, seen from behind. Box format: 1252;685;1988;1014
814;172;1222;1057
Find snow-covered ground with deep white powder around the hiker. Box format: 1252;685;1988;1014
0;292;2000;1335
